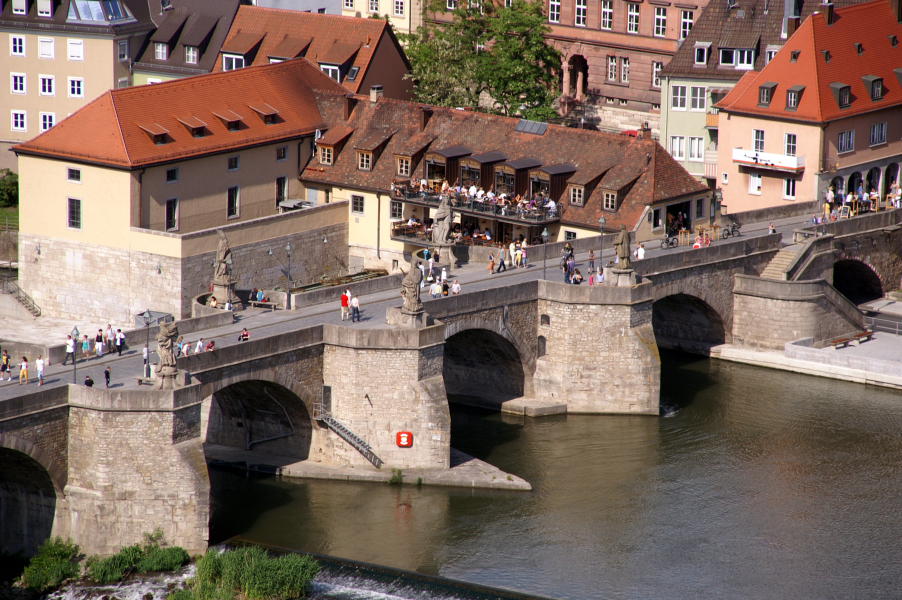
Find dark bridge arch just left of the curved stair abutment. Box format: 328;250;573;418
652;293;727;352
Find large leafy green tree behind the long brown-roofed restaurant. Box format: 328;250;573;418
405;0;561;120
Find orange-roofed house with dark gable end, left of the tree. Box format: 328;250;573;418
214;6;412;99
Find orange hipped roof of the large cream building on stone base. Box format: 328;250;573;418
13;59;346;169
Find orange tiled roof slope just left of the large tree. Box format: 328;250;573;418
215;6;400;92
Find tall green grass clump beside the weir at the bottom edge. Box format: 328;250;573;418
175;547;320;600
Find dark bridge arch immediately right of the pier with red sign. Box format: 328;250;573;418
442;321;527;409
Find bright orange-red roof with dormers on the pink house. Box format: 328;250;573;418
718;0;902;123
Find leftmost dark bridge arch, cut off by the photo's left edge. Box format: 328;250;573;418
0;434;64;556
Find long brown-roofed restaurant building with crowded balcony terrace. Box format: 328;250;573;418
301;88;710;267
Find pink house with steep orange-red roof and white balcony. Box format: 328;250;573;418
717;0;902;212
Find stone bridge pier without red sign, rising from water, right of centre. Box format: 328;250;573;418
533;281;661;415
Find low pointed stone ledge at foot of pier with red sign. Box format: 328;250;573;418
205;444;532;491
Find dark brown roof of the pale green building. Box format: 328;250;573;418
662;0;862;81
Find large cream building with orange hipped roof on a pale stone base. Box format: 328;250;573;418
14;59;347;325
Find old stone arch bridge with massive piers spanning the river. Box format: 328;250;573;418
0;211;902;553
